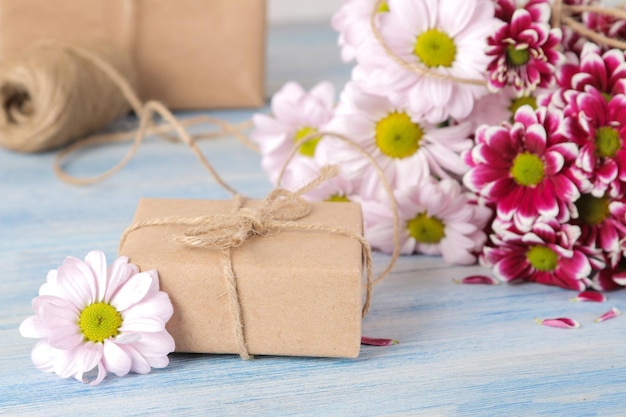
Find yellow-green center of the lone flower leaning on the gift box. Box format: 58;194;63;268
78;302;122;343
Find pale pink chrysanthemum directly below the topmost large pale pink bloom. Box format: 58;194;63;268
318;83;472;196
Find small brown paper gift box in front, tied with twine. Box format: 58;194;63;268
120;199;363;358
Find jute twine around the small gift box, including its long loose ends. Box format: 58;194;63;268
54;45;399;359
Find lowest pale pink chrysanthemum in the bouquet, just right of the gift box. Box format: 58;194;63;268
363;179;491;265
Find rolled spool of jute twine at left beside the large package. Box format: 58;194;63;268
0;41;136;152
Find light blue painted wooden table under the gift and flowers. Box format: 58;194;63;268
0;20;626;416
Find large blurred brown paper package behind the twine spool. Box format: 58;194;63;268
0;0;265;109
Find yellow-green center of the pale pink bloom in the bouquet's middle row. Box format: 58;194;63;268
376;113;424;158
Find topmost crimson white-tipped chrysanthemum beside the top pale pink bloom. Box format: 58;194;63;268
487;1;563;95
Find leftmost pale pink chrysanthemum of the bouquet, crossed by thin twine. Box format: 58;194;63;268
250;81;335;188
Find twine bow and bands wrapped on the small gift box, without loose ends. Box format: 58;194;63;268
120;166;373;360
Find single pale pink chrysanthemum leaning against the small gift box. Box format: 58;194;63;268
20;251;174;385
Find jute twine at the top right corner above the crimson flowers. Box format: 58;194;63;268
552;0;626;50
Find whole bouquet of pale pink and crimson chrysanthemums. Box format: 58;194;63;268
251;0;626;290
